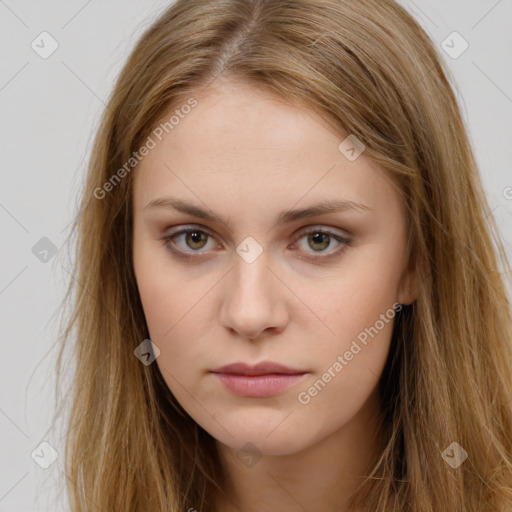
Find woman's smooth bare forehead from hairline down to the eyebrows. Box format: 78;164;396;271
131;83;400;220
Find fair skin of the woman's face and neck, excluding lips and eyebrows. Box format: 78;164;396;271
133;82;418;512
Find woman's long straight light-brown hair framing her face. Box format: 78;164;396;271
52;0;512;512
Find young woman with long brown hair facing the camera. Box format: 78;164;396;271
58;0;512;512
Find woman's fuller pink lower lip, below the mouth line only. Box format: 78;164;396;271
211;373;306;398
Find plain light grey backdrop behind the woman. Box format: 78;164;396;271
0;0;512;512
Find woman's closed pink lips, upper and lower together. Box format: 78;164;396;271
212;361;308;398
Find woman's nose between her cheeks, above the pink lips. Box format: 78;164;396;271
220;251;290;340
